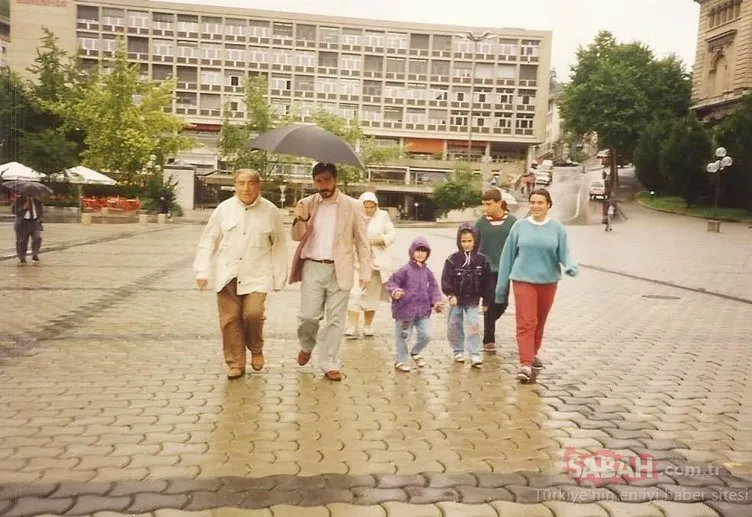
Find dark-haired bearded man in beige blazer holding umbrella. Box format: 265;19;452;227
290;163;373;381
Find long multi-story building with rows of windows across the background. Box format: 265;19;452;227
11;0;551;212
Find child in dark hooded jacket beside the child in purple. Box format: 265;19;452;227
441;223;495;368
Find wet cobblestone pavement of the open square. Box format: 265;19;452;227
0;209;752;517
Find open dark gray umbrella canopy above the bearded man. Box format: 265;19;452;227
247;124;364;168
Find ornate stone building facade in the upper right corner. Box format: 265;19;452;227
692;0;752;120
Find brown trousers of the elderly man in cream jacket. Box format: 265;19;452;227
217;279;266;370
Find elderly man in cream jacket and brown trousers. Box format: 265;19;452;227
194;169;287;379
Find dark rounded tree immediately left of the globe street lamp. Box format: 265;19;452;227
660;115;712;207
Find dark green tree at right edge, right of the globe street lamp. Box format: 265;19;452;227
706;94;752;211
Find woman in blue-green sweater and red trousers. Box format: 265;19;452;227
496;188;579;383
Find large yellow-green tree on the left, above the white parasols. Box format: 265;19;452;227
55;40;194;185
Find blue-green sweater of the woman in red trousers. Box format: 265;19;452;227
496;218;579;303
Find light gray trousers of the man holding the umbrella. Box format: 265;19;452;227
298;260;350;372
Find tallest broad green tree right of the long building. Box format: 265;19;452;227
560;31;690;184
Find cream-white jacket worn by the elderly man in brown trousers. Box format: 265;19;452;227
193;196;287;295
